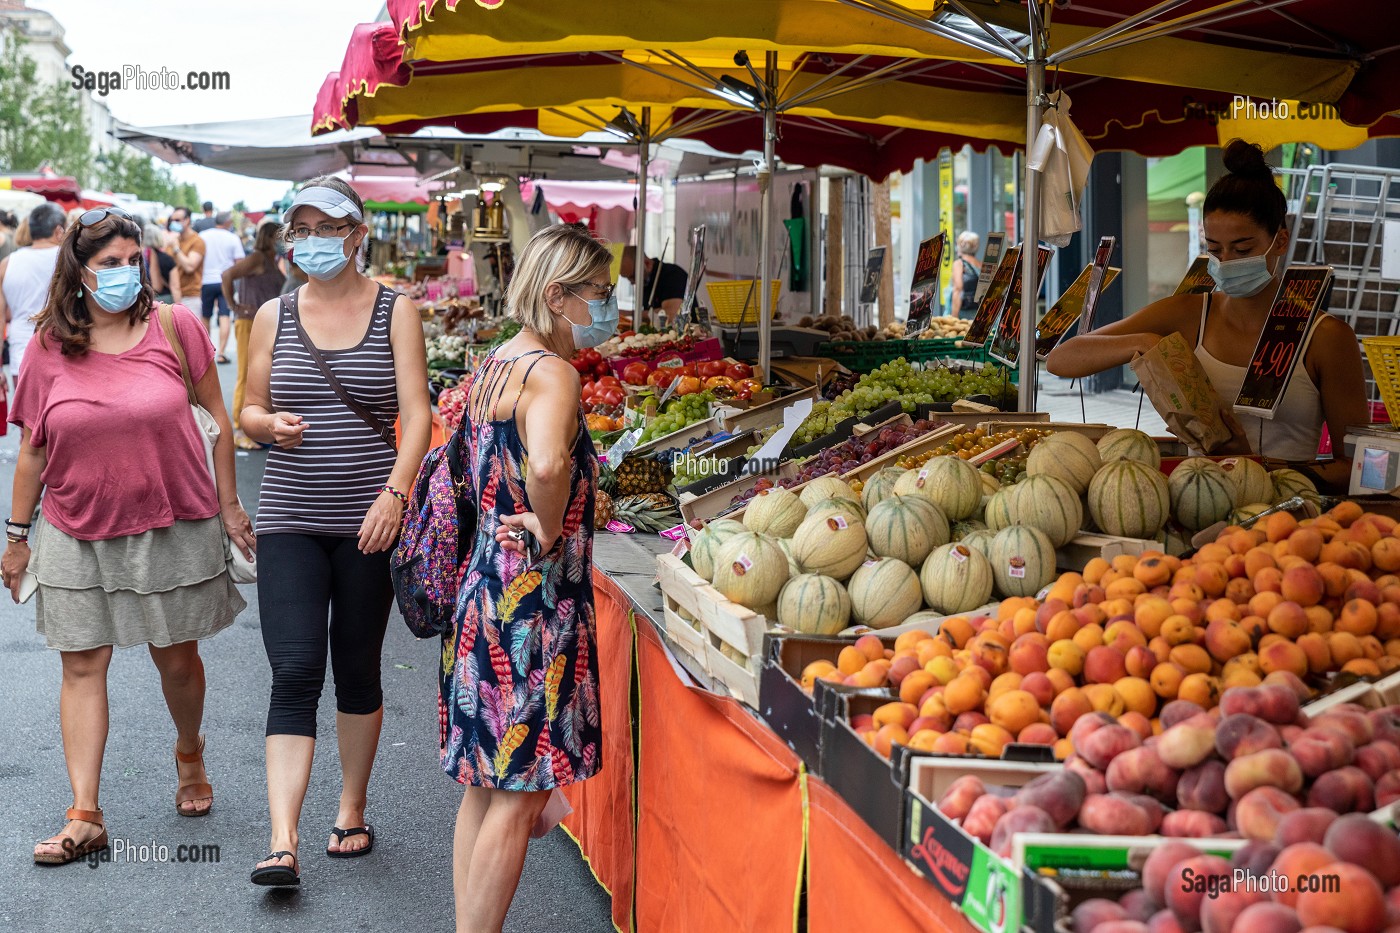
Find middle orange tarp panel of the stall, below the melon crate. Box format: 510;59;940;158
637;625;804;933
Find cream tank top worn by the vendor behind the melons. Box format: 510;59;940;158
1196;293;1326;461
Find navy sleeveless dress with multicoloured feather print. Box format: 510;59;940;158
438;350;602;790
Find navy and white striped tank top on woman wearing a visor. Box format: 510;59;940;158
258;286;399;537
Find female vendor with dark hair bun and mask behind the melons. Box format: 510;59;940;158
1046;139;1369;493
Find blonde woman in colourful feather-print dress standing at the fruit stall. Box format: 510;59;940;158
440;224;617;930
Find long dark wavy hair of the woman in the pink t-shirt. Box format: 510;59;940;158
34;214;155;356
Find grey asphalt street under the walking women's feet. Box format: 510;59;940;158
0;347;612;933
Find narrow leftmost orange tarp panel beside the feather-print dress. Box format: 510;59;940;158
563;572;636;933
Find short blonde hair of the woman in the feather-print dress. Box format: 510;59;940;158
505;224;612;336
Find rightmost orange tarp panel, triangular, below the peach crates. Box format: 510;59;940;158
806;778;976;933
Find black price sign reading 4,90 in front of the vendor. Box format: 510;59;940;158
1235;266;1331;419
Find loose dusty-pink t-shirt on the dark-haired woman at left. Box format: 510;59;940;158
10;304;218;541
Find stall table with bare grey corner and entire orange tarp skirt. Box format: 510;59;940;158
574;535;972;933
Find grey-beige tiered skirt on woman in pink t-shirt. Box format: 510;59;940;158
29;513;248;651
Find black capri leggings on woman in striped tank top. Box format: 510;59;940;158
258;534;393;737
